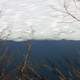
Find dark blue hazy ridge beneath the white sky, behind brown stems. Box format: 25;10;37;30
0;40;80;79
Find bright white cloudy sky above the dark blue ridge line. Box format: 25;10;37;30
0;0;80;41
